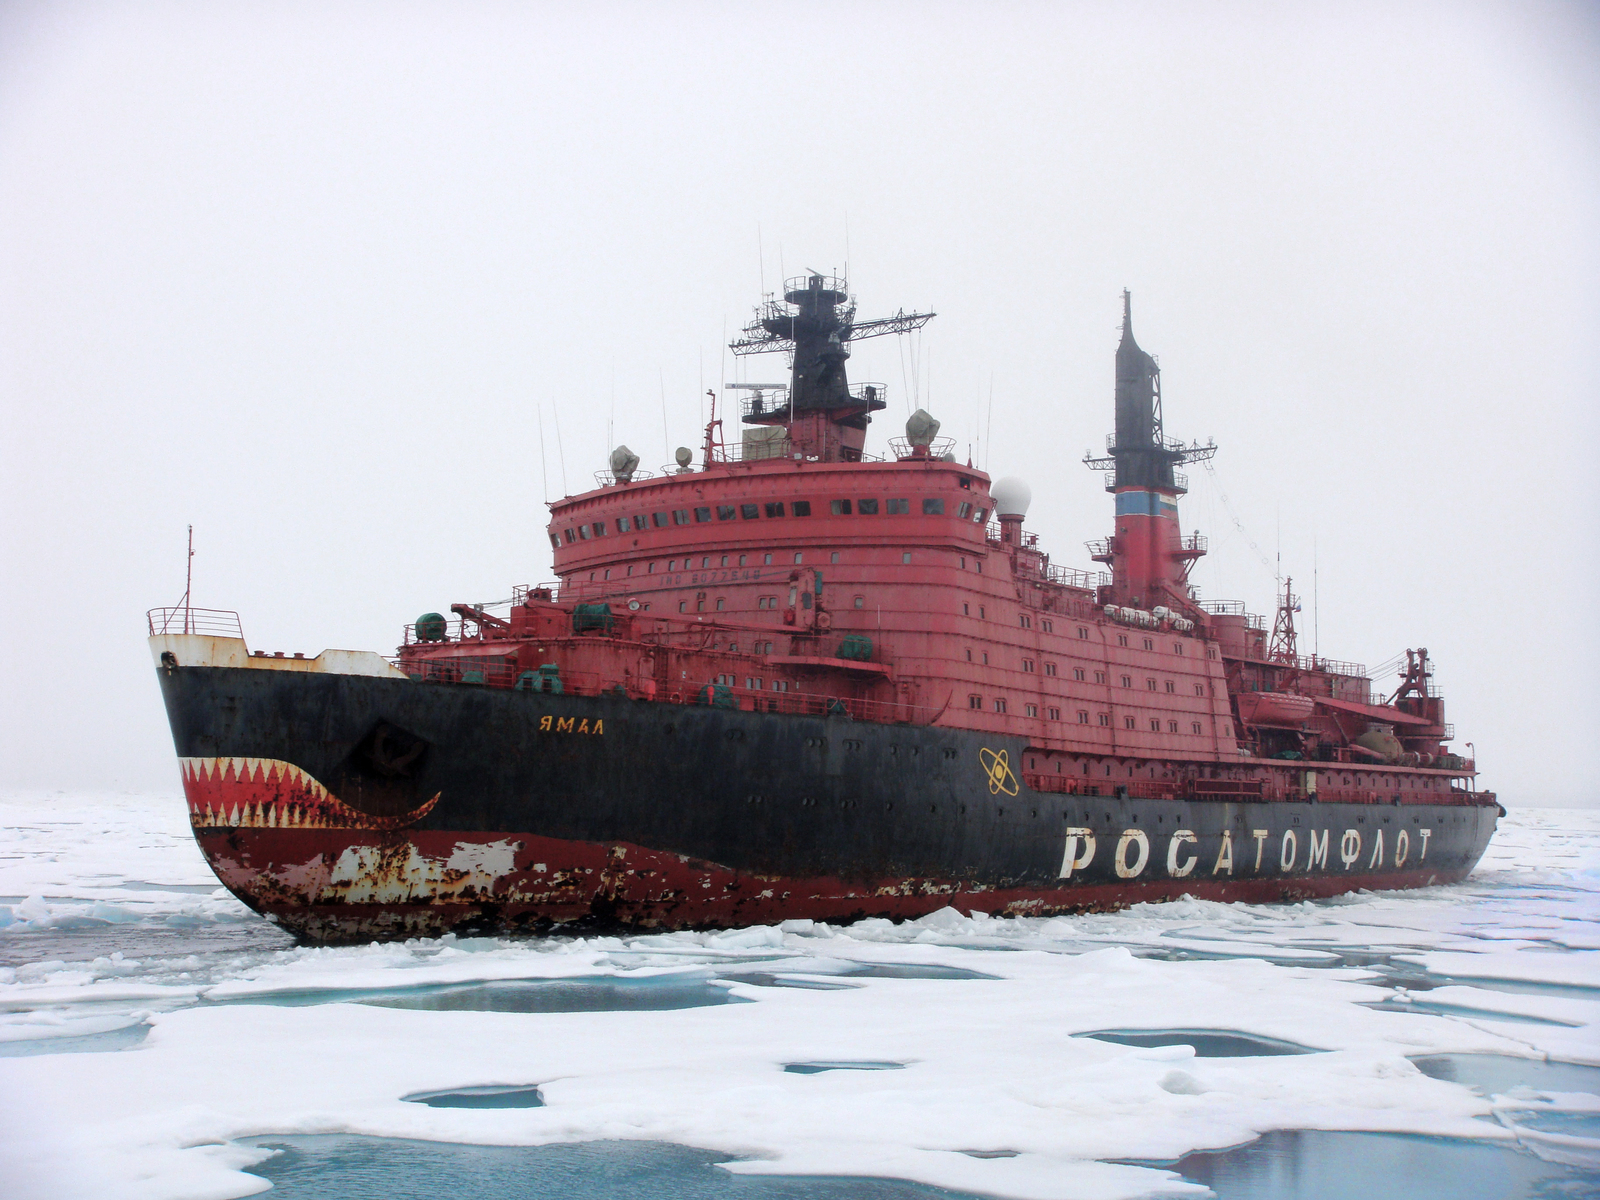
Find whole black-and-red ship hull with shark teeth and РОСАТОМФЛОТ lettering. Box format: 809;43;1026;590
158;667;1499;942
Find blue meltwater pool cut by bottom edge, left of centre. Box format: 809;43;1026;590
251;1136;979;1200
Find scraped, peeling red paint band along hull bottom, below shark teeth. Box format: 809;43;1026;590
195;827;1466;942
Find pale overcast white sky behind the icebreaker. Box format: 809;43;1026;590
0;0;1600;805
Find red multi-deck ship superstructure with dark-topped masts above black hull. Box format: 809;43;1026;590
402;275;1472;809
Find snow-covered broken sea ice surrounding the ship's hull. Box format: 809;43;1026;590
0;794;1600;1200
